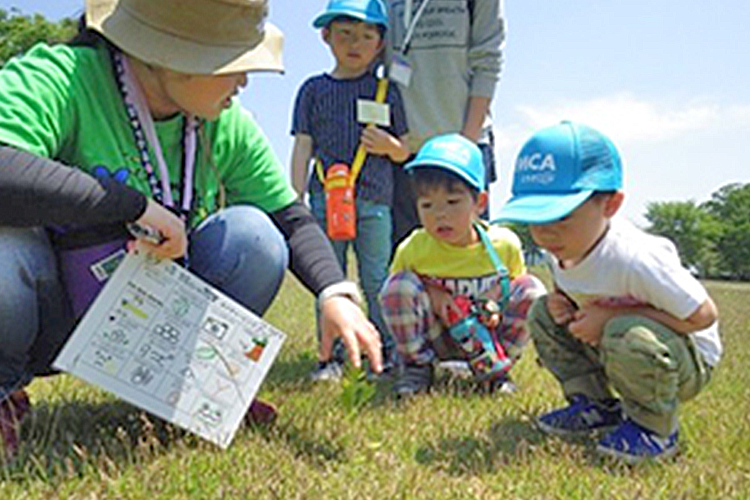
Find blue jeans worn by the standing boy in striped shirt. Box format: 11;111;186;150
310;194;394;358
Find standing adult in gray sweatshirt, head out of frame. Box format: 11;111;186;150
388;0;505;248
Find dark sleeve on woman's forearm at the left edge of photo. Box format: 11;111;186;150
0;145;146;227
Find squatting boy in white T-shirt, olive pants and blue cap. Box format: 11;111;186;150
499;122;722;464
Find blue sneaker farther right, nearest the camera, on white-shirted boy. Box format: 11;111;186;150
596;419;678;465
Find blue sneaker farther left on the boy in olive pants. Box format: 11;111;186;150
536;394;623;436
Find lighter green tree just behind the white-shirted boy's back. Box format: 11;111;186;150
644;200;722;276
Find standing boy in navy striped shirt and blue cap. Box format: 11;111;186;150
291;0;409;381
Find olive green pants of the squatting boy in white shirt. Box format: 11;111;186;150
528;296;711;436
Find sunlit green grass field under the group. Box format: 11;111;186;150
0;278;750;500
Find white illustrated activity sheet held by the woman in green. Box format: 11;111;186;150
54;252;286;448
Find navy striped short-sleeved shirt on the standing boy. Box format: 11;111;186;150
292;72;407;206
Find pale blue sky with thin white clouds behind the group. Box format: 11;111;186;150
5;0;750;225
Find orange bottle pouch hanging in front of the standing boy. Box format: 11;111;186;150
324;163;357;240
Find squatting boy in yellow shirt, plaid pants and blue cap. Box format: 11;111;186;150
381;134;544;397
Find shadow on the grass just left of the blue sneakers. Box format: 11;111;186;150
415;418;544;476
